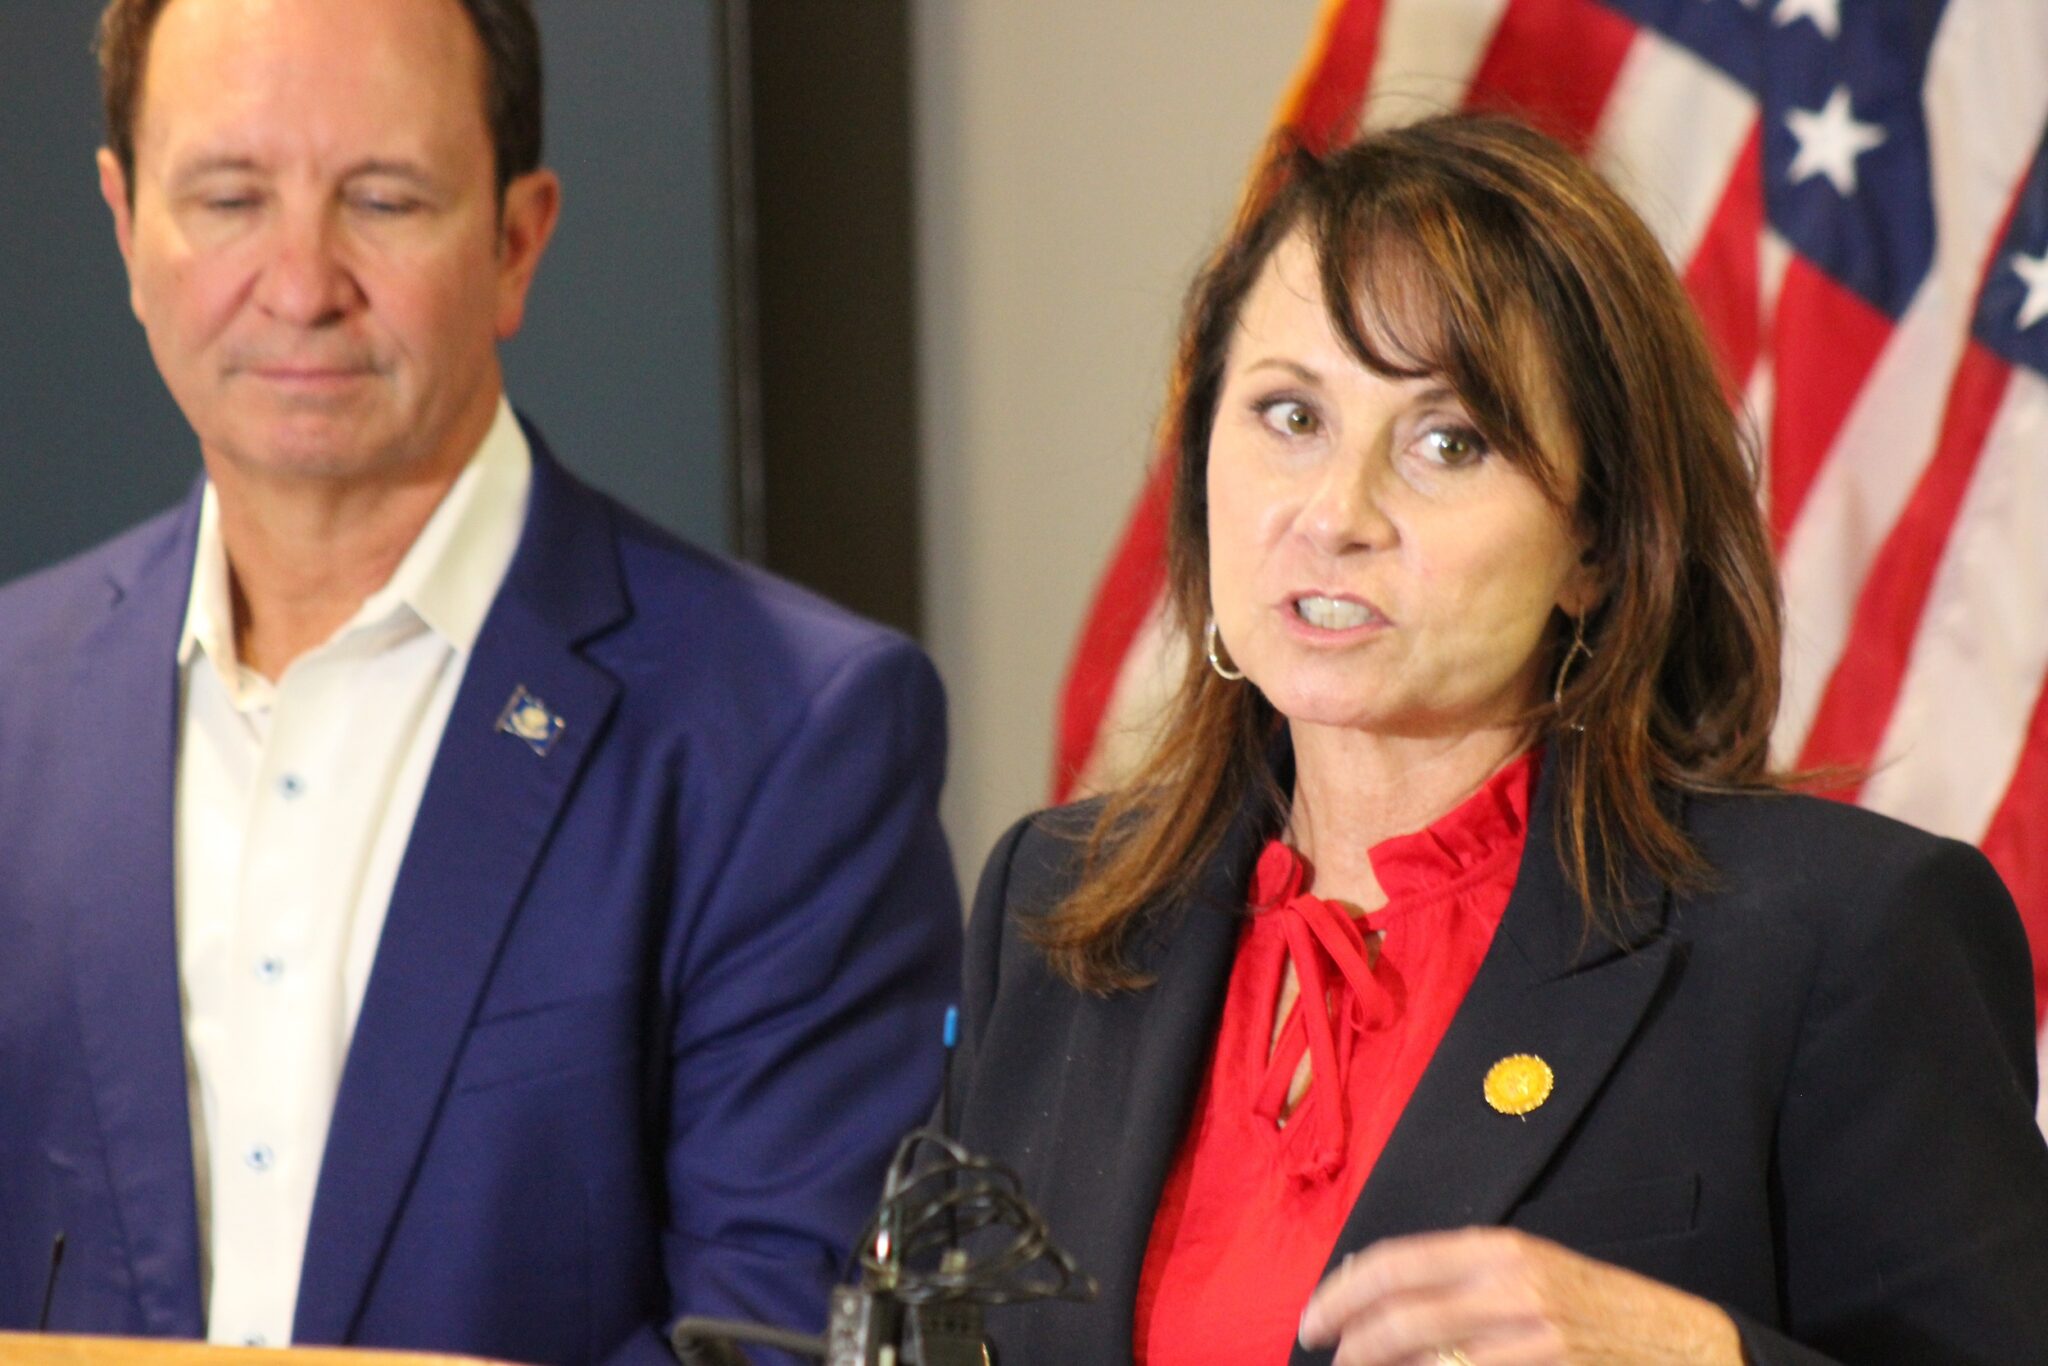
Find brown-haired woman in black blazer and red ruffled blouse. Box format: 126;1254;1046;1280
952;117;2048;1366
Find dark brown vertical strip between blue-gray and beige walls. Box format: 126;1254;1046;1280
729;0;922;635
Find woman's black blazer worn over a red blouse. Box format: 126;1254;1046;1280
950;772;2048;1366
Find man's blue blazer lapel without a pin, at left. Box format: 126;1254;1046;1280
60;492;205;1337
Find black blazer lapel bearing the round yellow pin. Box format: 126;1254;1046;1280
1292;764;1677;1366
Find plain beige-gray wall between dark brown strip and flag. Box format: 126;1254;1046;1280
911;0;1319;887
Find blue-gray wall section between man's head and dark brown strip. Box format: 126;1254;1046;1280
506;0;733;549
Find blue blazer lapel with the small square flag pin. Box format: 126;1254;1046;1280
293;448;627;1343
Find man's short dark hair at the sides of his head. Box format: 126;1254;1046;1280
96;0;541;203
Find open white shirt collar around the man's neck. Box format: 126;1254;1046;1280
178;397;532;696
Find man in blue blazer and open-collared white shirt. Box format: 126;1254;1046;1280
0;0;958;1362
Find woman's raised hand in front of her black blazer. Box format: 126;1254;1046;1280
1300;1229;1743;1366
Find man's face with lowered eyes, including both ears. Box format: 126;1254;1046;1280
100;0;559;491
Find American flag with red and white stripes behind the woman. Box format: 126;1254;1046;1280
1055;0;2048;1128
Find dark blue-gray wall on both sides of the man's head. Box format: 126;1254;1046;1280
0;0;733;580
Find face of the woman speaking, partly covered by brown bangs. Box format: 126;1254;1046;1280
1208;233;1597;737
